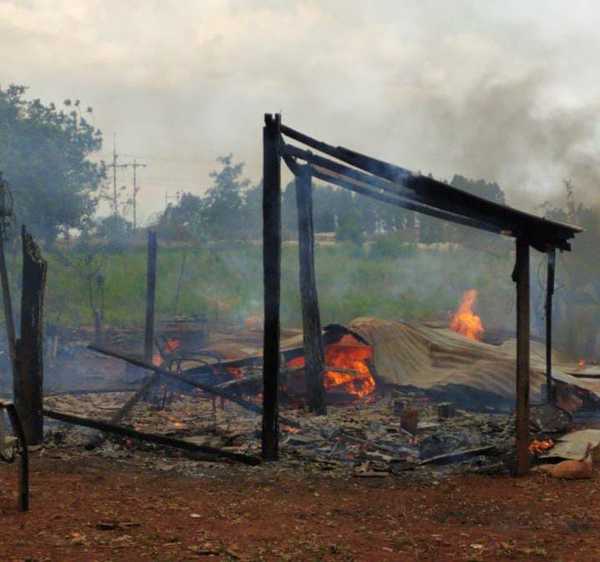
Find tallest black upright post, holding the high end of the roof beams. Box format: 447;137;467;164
262;114;281;461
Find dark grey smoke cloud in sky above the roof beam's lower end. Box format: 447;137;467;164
394;71;600;207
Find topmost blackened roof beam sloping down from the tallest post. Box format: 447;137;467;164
281;125;581;252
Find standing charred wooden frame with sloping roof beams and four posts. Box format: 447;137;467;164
262;114;581;474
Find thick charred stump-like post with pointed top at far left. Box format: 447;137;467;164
13;226;47;445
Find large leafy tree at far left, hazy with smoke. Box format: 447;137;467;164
0;85;105;244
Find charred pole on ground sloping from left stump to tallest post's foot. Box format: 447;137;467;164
44;408;260;466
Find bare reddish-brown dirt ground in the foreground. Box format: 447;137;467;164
0;457;600;562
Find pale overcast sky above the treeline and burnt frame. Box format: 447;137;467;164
0;0;600;221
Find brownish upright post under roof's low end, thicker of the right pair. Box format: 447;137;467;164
514;238;530;476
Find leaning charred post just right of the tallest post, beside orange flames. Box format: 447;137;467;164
296;166;327;415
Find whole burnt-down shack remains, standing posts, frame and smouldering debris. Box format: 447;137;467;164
0;114;588;508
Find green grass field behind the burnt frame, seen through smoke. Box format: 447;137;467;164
3;238;514;327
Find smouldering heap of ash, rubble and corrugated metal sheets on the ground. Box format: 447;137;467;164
45;312;584;478
